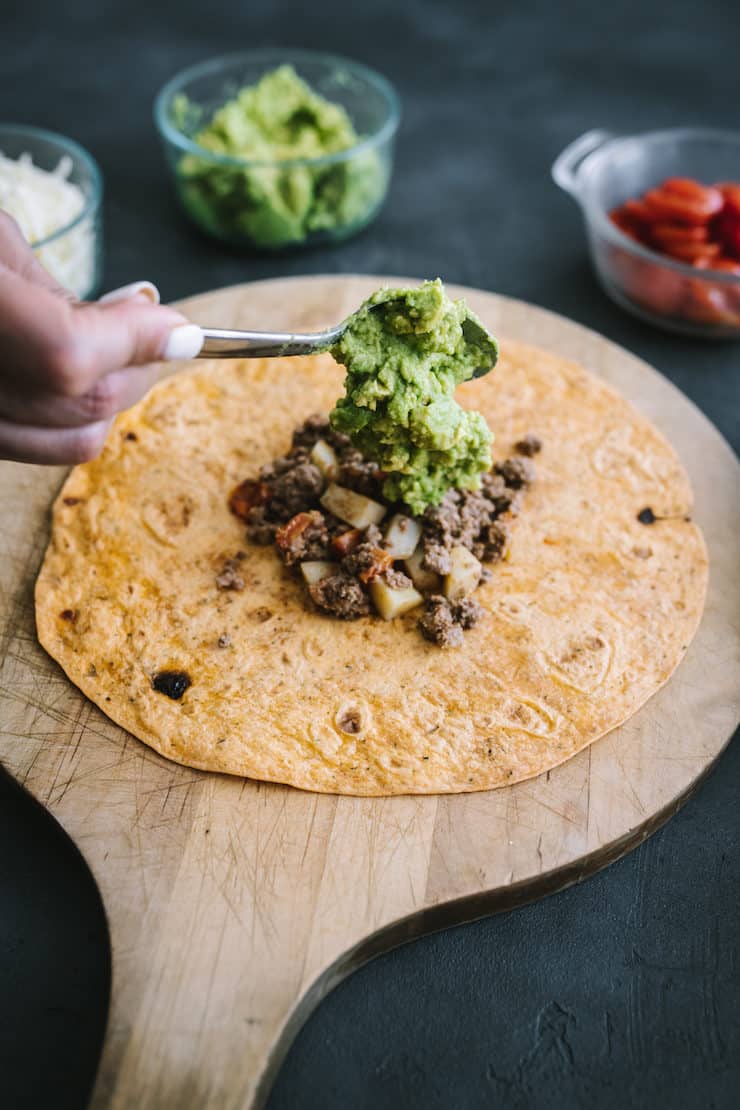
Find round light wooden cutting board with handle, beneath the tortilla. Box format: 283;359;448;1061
0;276;740;1110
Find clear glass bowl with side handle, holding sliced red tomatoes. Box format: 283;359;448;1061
553;128;740;339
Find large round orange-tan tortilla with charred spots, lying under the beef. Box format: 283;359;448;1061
36;342;707;795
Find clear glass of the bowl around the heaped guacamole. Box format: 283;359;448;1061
154;49;399;251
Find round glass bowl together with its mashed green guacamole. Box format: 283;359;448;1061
154;50;399;251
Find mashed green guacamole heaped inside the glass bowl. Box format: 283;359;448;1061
174;65;388;248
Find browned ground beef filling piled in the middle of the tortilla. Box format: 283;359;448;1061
227;415;541;647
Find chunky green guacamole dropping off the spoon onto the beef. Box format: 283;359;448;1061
331;279;498;514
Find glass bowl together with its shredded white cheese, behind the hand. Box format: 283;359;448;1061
0;123;103;300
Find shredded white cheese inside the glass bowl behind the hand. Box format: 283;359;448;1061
0;151;95;297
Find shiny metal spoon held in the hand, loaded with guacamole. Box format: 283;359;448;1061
197;301;497;377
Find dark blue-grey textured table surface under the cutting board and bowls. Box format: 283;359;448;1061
0;0;740;1110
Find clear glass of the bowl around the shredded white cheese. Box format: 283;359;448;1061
0;123;103;300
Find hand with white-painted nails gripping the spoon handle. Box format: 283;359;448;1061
0;212;202;463
